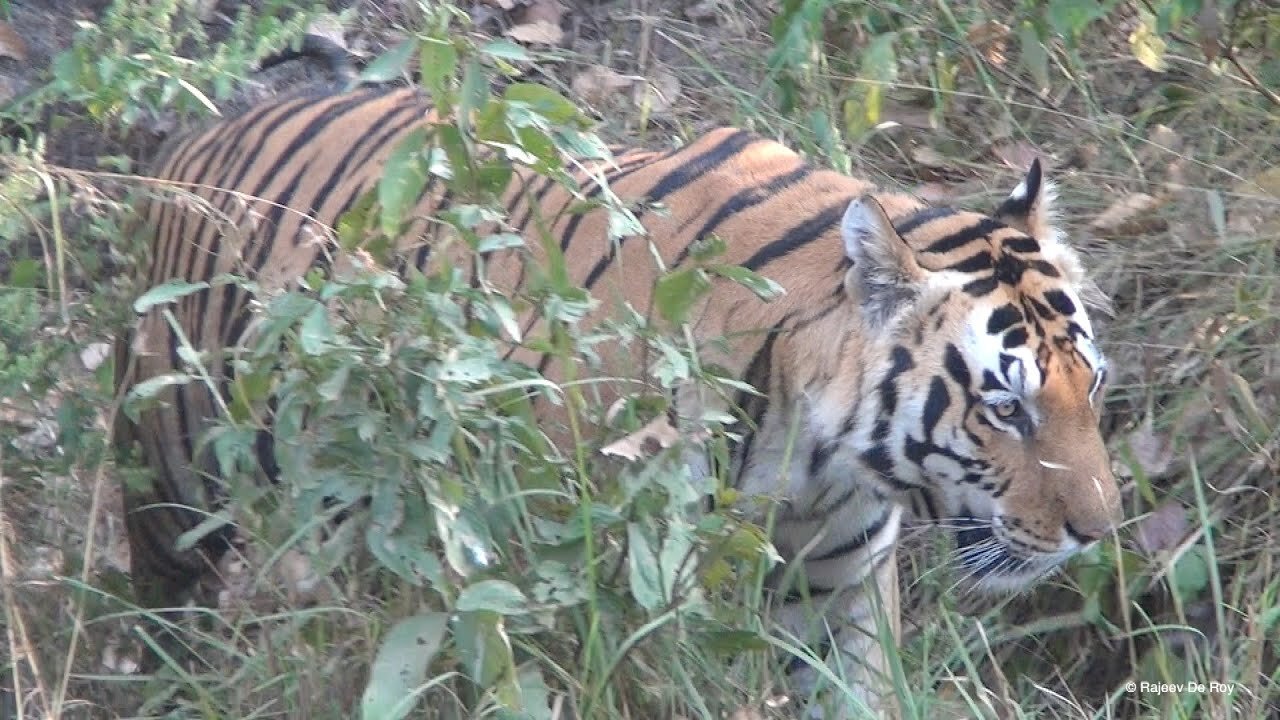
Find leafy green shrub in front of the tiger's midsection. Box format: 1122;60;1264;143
117;9;780;719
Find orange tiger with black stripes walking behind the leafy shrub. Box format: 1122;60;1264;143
116;88;1120;707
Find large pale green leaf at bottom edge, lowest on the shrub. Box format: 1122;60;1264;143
360;612;449;720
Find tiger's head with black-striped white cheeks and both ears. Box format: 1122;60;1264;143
841;161;1120;591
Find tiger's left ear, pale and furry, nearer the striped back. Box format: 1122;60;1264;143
840;195;929;323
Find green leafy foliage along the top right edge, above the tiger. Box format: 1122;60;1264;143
767;0;1280;151
